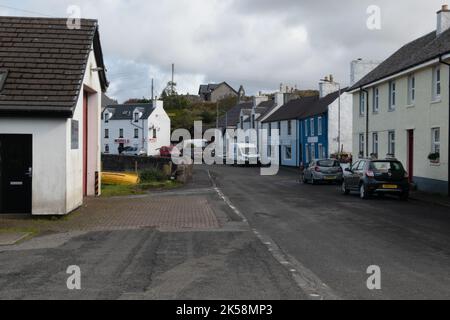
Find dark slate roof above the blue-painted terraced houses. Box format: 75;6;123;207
264;88;348;123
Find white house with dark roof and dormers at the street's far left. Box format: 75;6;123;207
102;101;171;156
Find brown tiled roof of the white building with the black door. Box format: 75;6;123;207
0;17;108;117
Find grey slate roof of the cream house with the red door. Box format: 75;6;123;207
349;29;450;90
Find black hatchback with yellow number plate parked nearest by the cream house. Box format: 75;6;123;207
342;159;410;200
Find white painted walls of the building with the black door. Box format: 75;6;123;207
0;48;101;215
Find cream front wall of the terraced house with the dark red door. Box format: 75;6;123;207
353;65;449;188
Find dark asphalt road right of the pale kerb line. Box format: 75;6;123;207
209;166;450;299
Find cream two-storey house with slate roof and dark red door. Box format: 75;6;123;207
349;6;450;193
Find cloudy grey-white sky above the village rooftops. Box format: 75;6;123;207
0;0;444;101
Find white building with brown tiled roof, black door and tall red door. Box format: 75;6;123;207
0;17;108;215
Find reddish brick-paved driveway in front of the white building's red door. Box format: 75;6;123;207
0;195;220;232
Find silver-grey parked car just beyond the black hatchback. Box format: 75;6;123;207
303;159;344;184
